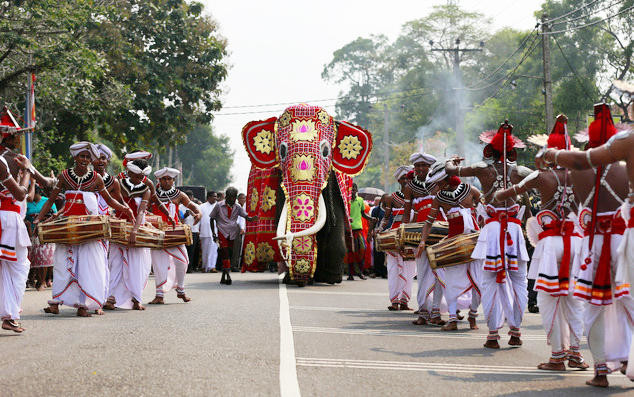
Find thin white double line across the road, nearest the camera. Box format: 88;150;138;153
297;357;592;378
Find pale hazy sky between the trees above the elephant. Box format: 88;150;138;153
199;0;542;192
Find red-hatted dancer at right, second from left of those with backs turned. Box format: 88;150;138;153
494;115;588;371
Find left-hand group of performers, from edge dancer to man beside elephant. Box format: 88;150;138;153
0;135;253;333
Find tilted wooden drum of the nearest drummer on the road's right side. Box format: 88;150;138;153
427;232;480;269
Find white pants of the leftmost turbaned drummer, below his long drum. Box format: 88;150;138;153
48;241;108;310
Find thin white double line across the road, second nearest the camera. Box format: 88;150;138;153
293;325;546;342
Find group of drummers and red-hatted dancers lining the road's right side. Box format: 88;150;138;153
372;104;634;387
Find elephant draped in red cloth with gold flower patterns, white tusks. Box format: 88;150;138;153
242;104;372;285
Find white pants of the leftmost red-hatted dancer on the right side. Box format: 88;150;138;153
480;261;528;332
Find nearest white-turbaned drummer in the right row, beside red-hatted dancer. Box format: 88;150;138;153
416;163;482;331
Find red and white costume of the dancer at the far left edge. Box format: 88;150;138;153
0;156;31;320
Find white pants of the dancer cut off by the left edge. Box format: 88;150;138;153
0;246;30;320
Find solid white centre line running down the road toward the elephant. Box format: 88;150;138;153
279;275;301;397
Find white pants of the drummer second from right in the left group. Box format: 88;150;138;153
108;244;151;309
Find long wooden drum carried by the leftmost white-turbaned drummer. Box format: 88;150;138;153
37;215;110;245
